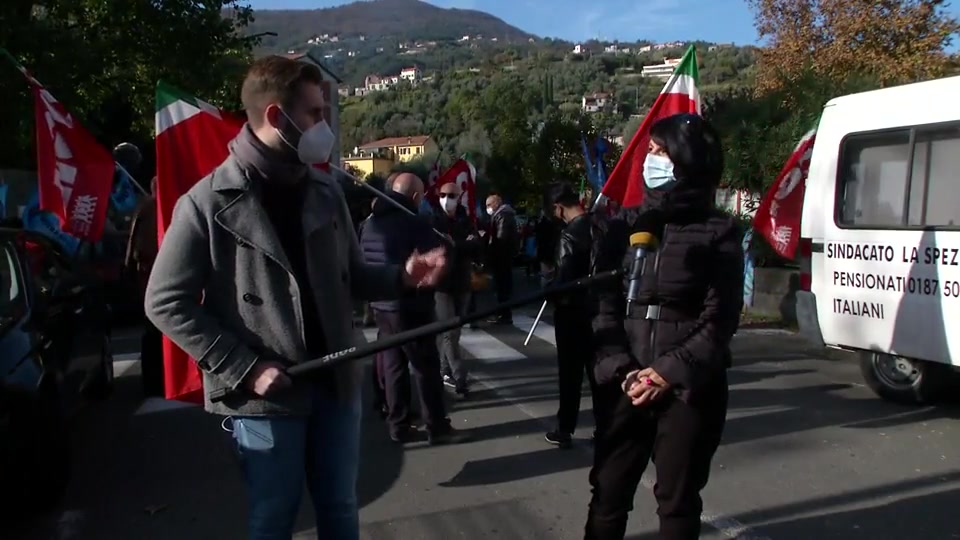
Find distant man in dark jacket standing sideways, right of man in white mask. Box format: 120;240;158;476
487;194;520;324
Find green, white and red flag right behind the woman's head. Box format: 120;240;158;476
600;45;700;208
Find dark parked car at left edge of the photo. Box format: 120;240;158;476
0;229;113;512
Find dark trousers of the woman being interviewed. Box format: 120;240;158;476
584;373;728;540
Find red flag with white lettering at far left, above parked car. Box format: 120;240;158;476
28;75;115;242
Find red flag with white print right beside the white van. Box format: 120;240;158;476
753;128;817;259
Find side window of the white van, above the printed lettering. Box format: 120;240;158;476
837;125;960;228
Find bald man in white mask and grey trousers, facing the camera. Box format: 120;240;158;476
434;182;478;398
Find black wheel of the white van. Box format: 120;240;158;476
860;351;954;405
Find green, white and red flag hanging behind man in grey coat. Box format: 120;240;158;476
156;82;243;403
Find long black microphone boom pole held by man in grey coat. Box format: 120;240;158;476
210;270;622;403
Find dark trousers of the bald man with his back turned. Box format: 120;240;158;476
374;310;449;434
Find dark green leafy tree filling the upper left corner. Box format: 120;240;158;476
0;0;255;168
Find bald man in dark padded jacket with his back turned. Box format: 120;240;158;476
360;173;464;444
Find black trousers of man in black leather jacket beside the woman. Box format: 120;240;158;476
553;306;601;434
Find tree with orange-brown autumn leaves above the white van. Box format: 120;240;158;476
748;0;960;93
